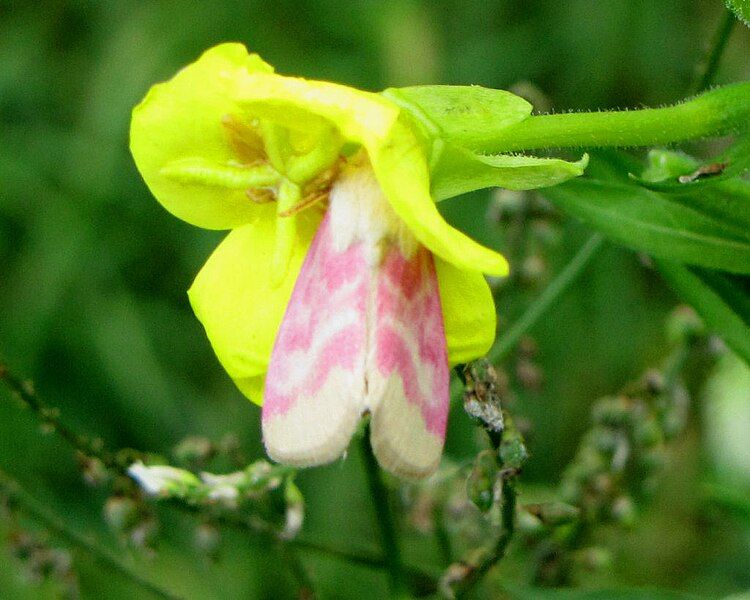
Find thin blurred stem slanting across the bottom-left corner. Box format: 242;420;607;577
0;471;180;600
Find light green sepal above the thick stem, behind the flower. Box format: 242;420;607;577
382;85;532;149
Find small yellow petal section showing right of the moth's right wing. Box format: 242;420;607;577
435;257;497;366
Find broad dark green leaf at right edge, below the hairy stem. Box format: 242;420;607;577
544;179;750;273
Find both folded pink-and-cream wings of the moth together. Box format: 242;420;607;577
262;210;449;478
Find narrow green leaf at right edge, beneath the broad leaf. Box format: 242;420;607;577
656;260;750;364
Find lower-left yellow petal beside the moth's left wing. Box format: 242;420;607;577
188;205;320;400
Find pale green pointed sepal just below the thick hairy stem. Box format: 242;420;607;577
432;146;588;200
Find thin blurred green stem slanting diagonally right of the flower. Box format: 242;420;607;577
487;233;604;364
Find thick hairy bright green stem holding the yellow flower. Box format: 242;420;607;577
476;82;750;153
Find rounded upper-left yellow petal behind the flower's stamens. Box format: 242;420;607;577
130;44;273;229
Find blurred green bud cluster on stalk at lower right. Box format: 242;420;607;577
520;308;705;585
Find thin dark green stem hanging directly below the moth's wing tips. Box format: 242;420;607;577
361;425;406;598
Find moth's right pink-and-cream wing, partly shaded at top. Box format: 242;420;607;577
367;245;450;478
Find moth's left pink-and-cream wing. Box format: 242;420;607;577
262;216;371;466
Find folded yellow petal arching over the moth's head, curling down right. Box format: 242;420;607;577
241;73;508;275
